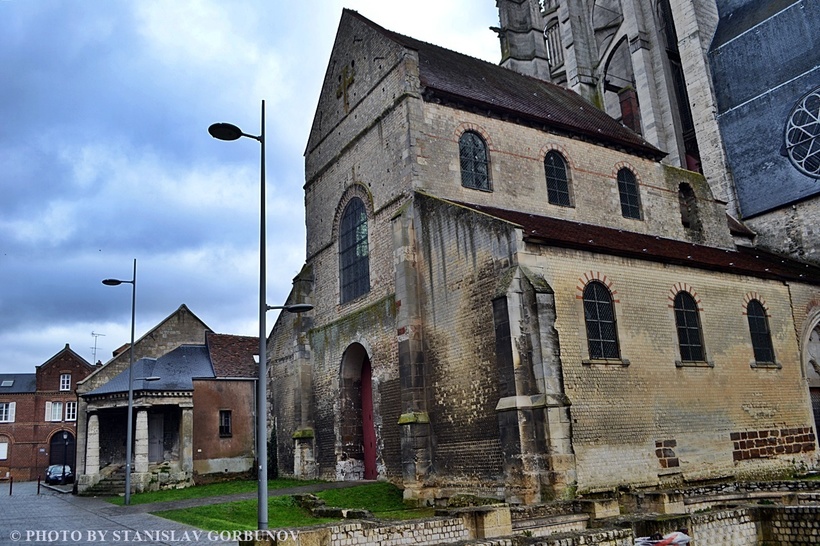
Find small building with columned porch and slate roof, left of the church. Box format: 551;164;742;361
77;305;259;493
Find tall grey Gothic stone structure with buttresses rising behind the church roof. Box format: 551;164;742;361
496;0;736;212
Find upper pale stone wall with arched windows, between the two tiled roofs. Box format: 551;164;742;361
418;99;731;247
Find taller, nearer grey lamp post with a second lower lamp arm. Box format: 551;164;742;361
208;100;313;530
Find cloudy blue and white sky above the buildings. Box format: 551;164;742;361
0;0;499;373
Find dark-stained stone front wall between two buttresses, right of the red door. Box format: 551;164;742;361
415;195;515;486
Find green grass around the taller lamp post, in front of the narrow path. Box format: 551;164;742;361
154;482;434;531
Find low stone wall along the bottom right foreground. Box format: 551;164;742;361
241;484;820;546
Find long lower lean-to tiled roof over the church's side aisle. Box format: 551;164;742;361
458;203;820;284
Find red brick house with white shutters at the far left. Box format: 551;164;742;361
0;344;94;481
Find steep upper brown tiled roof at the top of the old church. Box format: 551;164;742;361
345;10;666;159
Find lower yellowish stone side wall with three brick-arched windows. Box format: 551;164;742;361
522;247;817;492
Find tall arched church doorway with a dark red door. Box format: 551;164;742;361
337;343;378;480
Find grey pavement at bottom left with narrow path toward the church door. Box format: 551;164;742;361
0;482;370;546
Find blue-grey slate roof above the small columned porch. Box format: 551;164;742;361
83;345;214;396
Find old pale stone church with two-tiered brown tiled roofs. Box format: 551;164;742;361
268;8;820;502
